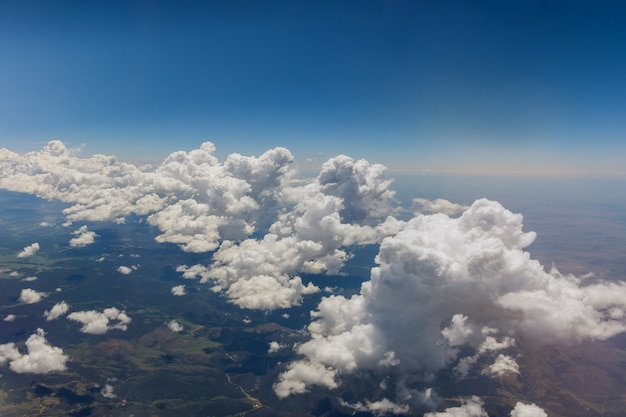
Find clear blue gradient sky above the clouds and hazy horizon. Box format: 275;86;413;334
0;0;626;173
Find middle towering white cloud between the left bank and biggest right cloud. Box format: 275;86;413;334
178;156;402;310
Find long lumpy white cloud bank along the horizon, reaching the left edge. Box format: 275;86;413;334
0;141;293;240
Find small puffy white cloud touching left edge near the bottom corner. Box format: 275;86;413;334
0;329;68;374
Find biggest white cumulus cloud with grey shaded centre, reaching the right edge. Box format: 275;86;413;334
274;199;626;404
